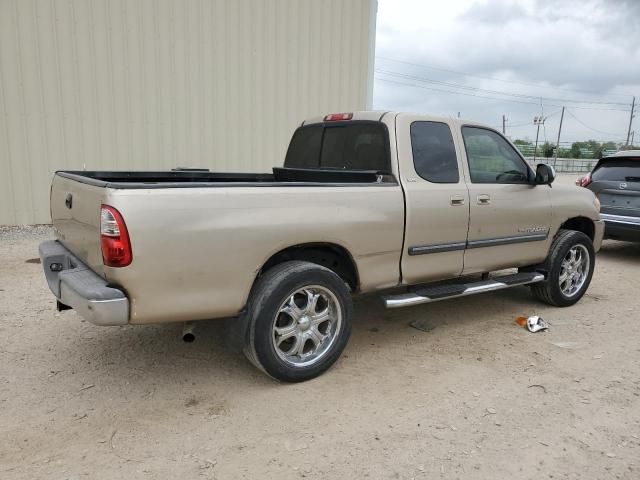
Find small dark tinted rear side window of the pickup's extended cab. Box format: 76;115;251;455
411;122;460;183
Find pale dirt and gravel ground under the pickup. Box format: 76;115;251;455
0;212;640;479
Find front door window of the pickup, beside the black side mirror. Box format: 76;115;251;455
462;127;532;183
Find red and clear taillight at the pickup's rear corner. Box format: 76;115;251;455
100;205;133;267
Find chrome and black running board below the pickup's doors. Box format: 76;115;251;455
382;272;544;308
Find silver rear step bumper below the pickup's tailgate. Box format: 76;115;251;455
39;240;129;325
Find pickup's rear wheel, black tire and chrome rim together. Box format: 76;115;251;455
243;261;353;382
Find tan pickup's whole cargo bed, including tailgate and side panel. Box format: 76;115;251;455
51;168;404;323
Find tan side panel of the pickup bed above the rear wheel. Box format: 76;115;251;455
104;185;404;323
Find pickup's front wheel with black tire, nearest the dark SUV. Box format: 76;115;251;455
531;230;596;307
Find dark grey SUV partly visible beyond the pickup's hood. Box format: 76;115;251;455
576;150;640;242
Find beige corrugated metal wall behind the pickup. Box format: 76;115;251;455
0;0;376;225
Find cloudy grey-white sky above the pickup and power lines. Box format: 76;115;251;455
373;0;640;144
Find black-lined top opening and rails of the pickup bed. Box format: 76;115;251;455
56;167;395;189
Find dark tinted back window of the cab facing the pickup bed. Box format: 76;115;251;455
284;121;391;173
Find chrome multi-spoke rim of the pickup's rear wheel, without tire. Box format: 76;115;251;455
272;285;342;367
